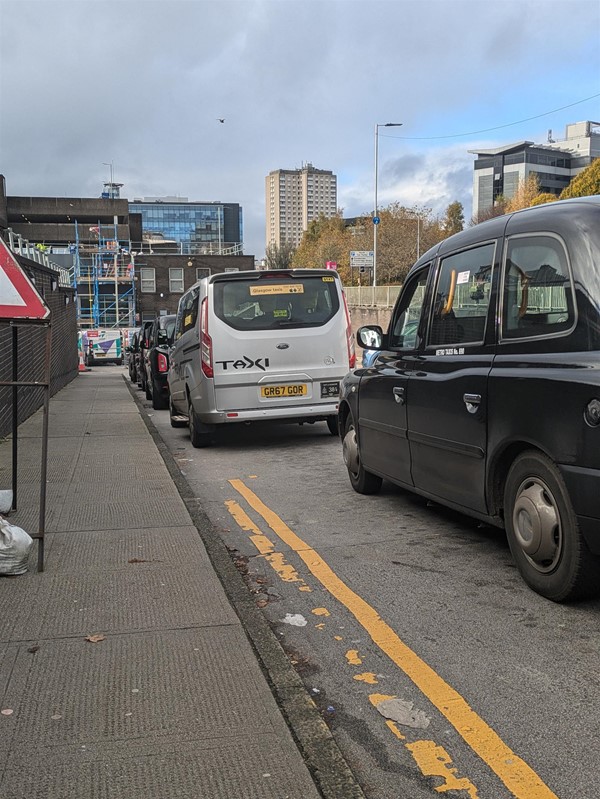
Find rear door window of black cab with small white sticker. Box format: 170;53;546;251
428;242;496;346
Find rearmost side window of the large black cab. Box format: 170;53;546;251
502;236;575;339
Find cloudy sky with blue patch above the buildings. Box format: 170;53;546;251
0;0;600;258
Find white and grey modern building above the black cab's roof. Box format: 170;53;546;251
469;122;600;216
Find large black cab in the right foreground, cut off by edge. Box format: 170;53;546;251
340;196;600;601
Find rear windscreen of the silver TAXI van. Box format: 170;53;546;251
213;275;340;330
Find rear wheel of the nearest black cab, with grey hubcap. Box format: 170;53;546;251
504;450;600;602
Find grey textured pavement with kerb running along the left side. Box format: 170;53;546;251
0;367;364;799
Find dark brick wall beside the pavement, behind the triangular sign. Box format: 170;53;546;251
0;257;79;436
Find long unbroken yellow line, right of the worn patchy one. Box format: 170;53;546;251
229;480;558;799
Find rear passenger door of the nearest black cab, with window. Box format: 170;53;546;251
407;241;497;512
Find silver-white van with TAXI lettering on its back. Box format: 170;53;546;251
169;269;355;447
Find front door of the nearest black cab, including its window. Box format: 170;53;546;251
358;265;431;486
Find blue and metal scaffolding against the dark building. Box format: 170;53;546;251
73;218;136;330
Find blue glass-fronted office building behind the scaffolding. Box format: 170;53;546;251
129;198;243;255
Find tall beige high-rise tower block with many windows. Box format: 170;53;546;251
265;163;337;247
